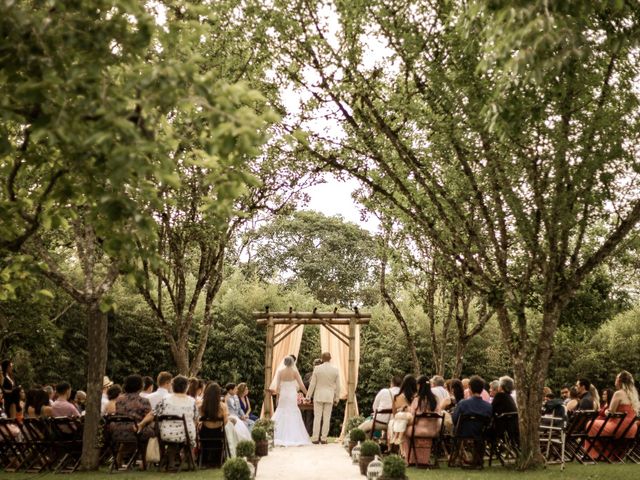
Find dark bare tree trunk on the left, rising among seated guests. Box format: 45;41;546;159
81;301;108;470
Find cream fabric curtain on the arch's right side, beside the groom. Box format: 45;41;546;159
320;325;360;438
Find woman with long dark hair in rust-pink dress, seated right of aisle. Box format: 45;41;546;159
401;375;441;465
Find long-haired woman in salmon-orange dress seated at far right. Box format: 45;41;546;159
585;370;640;460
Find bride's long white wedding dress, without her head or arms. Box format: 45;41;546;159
272;380;311;447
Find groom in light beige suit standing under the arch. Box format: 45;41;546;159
307;352;340;444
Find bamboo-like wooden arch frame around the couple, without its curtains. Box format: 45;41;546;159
253;307;371;418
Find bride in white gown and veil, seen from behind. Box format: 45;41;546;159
272;356;311;447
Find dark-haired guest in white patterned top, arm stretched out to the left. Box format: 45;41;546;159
138;375;198;446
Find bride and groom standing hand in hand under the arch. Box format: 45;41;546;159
272;352;340;447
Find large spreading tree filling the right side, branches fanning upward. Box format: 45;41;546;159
274;0;640;468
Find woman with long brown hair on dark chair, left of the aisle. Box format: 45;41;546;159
200;382;231;467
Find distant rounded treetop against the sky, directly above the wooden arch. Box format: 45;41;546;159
245;211;376;307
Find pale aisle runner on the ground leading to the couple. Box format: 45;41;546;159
257;443;364;480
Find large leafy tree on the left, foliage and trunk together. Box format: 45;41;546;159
0;0;272;469
